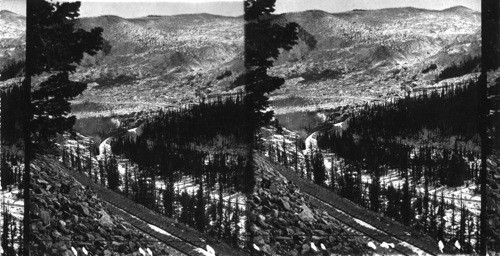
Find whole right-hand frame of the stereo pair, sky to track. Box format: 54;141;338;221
245;0;481;255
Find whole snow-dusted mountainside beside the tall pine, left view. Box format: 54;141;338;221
68;14;244;116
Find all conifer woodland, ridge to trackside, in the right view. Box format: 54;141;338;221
266;79;480;253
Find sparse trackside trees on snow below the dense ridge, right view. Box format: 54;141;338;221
267;136;479;253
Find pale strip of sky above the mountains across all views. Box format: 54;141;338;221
0;0;481;18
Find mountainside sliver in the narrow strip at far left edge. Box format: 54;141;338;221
0;10;26;69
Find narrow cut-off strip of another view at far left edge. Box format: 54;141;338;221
0;0;29;255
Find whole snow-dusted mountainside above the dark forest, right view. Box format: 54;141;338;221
273;7;481;113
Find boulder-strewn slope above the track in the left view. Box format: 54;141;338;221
30;157;178;255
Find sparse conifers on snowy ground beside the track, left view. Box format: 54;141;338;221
61;147;246;247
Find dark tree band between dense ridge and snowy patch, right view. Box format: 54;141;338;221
318;133;480;187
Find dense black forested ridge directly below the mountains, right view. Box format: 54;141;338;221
346;80;477;140
